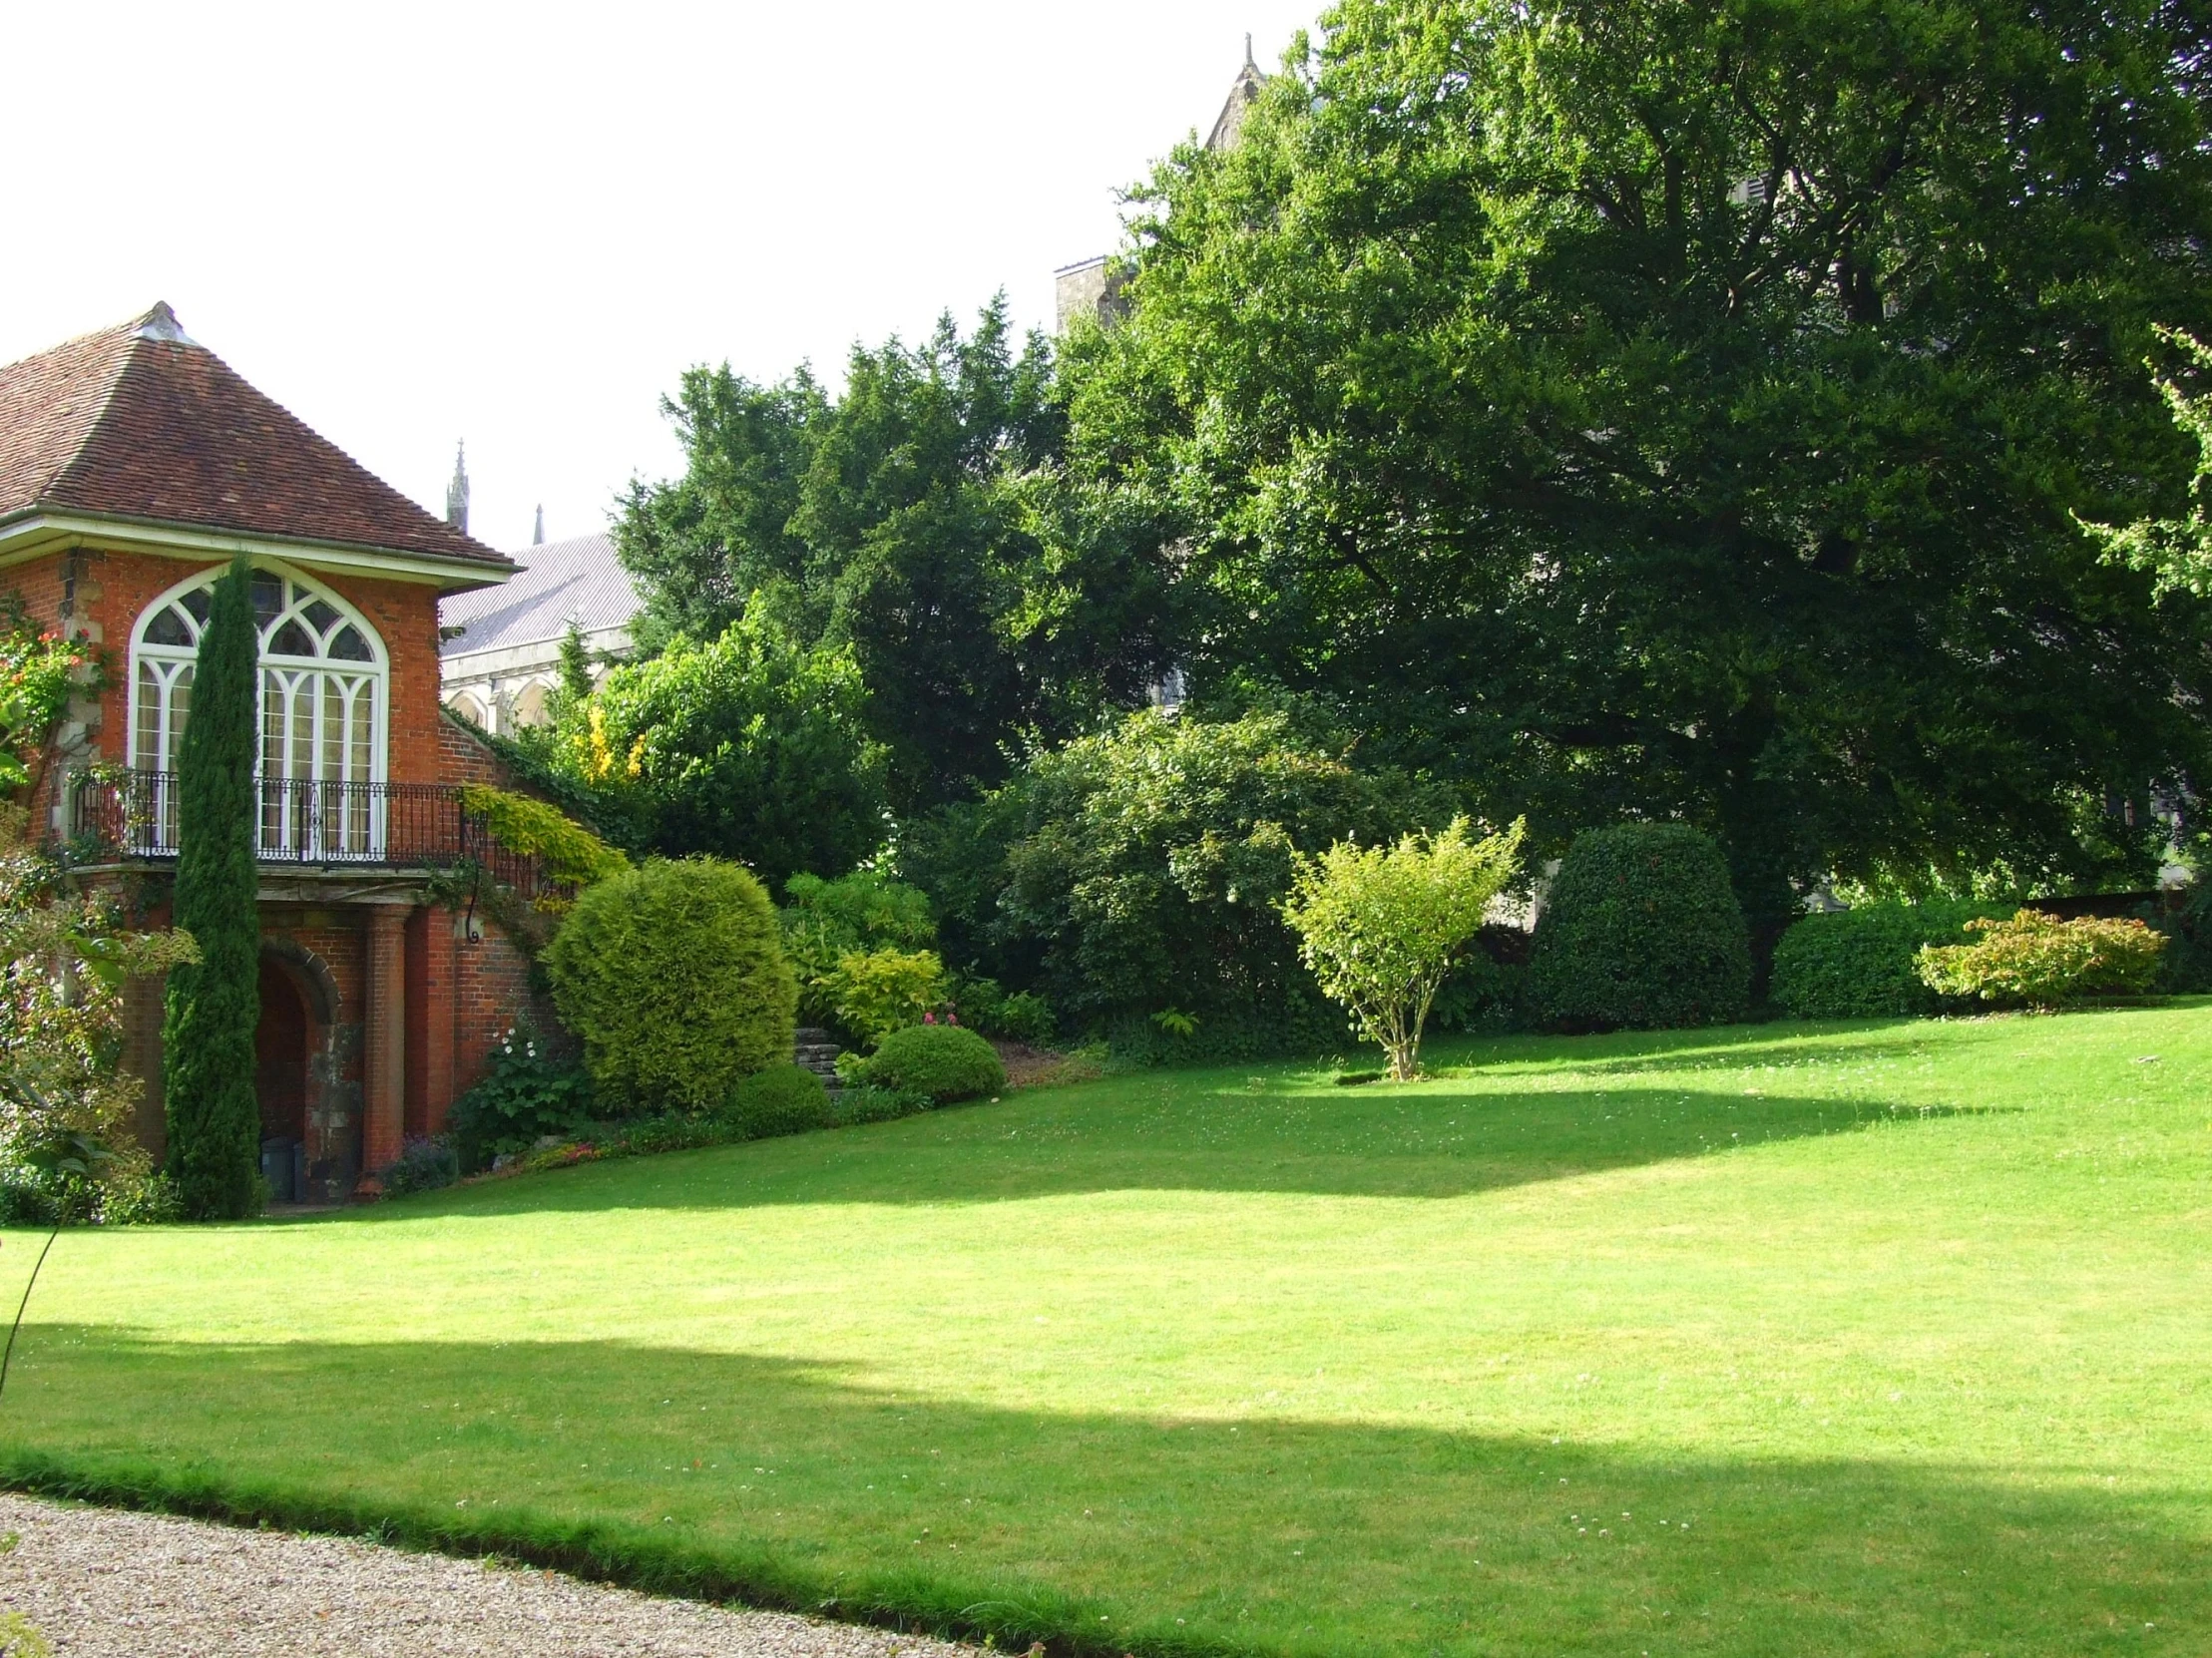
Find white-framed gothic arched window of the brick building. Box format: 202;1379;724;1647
131;569;387;849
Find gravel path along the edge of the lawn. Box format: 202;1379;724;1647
0;1492;973;1658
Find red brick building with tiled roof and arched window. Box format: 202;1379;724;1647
0;305;553;1200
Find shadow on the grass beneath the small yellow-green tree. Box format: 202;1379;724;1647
375;1078;1987;1225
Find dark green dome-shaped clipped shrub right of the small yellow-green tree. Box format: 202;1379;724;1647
1529;822;1752;1031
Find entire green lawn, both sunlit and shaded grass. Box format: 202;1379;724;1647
0;1004;2212;1658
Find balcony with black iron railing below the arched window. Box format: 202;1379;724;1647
69;771;564;900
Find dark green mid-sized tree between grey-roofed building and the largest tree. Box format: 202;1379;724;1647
615;300;1165;811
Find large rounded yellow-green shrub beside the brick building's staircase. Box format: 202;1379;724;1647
544;858;798;1112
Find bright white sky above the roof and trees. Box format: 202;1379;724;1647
0;0;1321;559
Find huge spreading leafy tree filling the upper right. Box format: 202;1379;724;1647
1064;0;2212;931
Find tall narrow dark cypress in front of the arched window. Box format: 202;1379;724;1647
162;555;261;1220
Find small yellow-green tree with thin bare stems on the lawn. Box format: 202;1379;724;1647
1283;818;1522;1083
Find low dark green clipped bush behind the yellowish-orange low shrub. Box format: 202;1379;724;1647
1767;900;2012;1020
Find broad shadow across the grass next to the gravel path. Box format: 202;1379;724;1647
0;1327;2212;1658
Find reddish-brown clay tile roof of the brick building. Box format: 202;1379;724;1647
0;305;507;571
